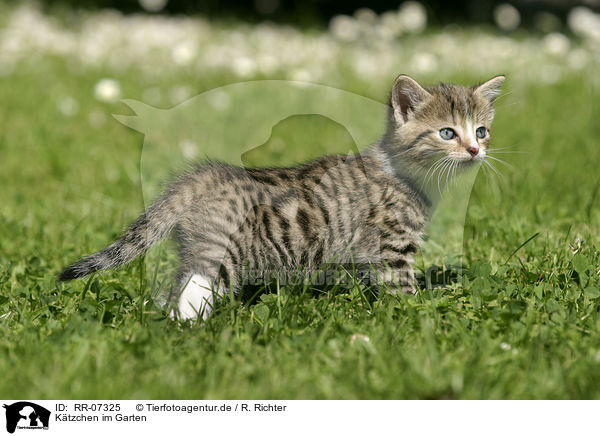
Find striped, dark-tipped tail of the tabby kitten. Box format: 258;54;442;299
58;192;182;282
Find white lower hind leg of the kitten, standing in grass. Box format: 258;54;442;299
169;273;224;320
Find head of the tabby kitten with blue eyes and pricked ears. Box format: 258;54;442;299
388;76;504;175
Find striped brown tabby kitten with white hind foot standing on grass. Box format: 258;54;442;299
59;75;504;319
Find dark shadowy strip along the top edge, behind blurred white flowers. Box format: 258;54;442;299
30;0;600;26
